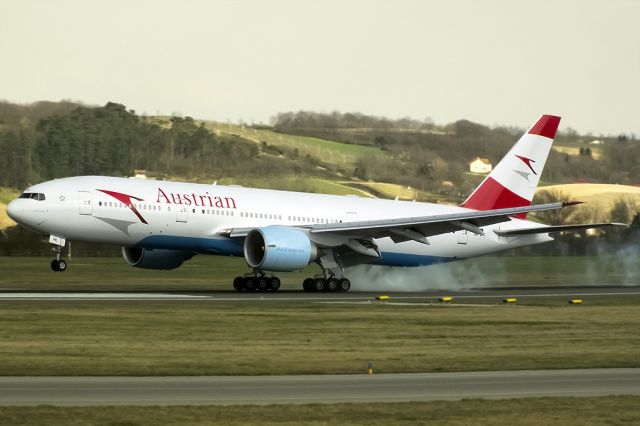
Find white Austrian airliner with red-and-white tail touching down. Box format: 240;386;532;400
7;115;616;291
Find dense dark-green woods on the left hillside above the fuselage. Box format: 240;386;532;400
0;102;312;188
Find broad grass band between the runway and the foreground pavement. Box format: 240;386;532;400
0;299;640;376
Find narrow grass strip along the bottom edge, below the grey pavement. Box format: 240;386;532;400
0;396;640;426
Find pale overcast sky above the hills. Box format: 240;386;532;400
0;0;640;135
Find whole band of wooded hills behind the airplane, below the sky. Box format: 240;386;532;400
0;101;640;197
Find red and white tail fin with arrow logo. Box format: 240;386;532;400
460;115;560;218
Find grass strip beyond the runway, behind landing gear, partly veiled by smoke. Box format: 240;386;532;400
0;255;640;291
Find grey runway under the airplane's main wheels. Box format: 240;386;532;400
0;285;640;303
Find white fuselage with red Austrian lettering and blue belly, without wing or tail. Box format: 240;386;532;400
9;176;552;266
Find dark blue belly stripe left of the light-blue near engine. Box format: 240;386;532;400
136;235;244;256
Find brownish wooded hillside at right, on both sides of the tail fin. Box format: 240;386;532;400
273;111;640;194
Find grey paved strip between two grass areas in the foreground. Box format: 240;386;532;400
0;368;640;405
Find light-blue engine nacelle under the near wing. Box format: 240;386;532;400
244;225;318;271
